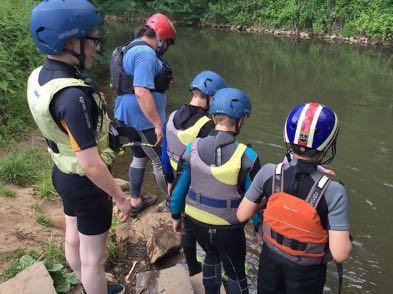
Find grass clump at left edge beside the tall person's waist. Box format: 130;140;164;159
0;148;52;187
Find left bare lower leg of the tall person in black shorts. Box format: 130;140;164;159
64;215;82;281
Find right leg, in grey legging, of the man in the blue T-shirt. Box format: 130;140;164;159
139;129;168;198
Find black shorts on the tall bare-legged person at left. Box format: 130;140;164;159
52;165;113;235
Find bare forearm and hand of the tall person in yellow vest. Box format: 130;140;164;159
75;147;130;216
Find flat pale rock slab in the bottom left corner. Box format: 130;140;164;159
0;262;56;294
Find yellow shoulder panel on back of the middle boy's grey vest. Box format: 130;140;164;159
211;143;247;186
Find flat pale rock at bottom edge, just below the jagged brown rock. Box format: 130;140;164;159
135;265;194;294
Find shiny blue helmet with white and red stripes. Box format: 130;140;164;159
284;103;339;151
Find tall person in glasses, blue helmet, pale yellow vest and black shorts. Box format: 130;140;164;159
27;0;131;294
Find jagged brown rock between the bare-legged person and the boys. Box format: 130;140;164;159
142;212;181;263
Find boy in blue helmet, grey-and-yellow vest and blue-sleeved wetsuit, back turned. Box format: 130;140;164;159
170;88;260;294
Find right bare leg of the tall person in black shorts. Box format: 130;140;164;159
79;232;108;294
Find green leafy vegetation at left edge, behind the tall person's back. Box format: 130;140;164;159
0;0;43;146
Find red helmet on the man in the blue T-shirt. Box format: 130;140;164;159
146;13;176;46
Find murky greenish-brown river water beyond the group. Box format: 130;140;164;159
93;22;393;293
